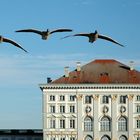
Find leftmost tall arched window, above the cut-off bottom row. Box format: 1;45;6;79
84;116;93;131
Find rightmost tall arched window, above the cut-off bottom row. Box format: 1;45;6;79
118;116;127;131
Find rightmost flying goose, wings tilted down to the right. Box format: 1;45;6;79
64;30;124;47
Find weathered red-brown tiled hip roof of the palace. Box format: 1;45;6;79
51;59;140;84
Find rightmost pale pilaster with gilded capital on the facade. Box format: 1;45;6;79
128;95;134;140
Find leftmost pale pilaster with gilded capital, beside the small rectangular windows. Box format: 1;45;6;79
77;95;83;140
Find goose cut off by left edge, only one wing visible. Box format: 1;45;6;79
0;35;27;52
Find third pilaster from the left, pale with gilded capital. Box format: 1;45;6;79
111;95;117;140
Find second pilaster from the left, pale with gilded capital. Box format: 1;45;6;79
93;95;99;140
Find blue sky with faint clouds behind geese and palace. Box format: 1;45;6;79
0;0;140;129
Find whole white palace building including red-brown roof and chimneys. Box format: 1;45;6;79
39;59;140;140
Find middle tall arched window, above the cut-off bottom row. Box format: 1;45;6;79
100;116;111;131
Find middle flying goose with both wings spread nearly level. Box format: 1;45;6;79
16;29;72;40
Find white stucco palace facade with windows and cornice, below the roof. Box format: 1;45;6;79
40;83;140;140
